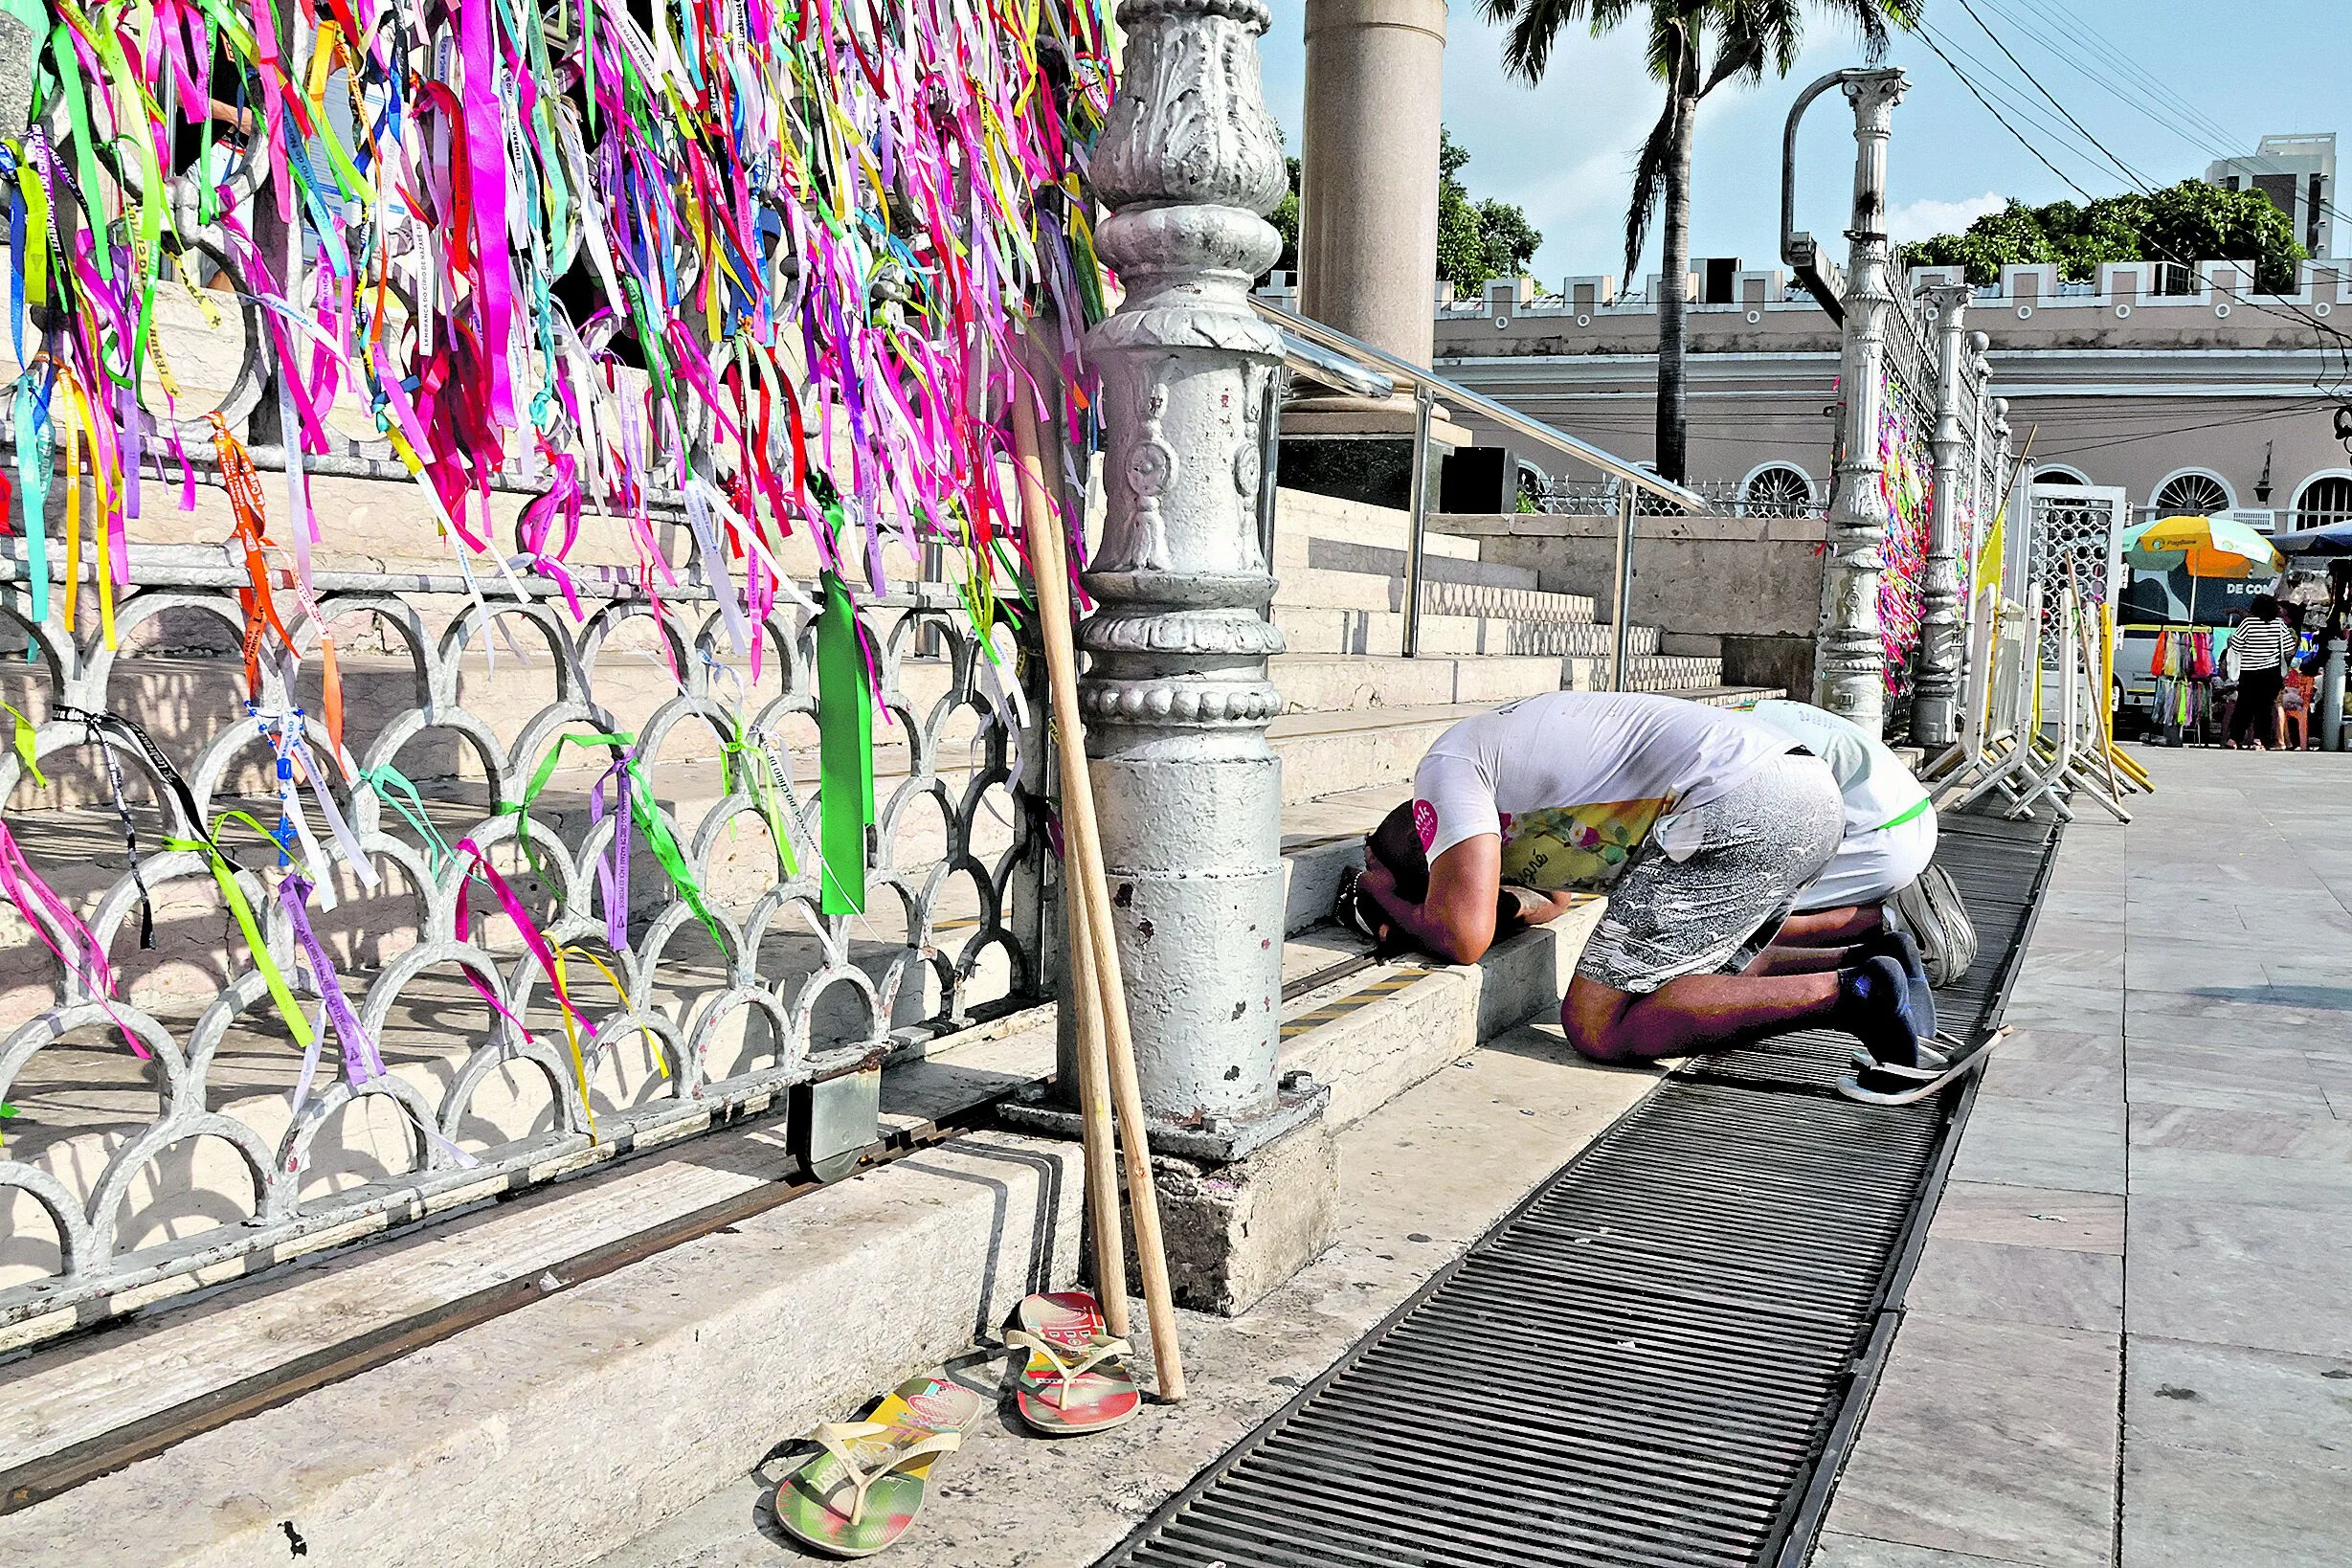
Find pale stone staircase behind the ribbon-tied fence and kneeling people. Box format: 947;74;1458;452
0;482;1797;1568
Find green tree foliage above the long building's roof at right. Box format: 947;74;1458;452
1898;179;2302;294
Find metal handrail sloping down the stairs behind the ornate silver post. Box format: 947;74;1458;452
1249;299;1714;691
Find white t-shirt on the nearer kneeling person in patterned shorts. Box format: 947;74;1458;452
1414;691;1790;893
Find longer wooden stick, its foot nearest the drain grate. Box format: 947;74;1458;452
1012;383;1183;1403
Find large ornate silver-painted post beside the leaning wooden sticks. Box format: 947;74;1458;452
1080;0;1287;1132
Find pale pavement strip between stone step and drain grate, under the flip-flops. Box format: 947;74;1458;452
595;1025;1656;1568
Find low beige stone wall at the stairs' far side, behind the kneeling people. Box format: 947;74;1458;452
1430;512;1823;693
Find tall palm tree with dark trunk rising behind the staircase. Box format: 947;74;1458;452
1482;0;1926;484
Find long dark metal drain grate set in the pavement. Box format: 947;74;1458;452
1101;830;2051;1568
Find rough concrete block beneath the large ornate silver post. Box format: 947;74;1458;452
1136;1114;1338;1316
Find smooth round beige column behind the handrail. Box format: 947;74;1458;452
1298;0;1446;365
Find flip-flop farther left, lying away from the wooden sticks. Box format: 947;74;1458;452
773;1376;985;1557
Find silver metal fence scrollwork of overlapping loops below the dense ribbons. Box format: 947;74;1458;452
0;533;1044;1326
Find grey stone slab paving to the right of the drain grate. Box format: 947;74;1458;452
1813;750;2352;1568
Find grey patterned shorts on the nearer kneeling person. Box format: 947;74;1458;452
1576;754;1844;995
